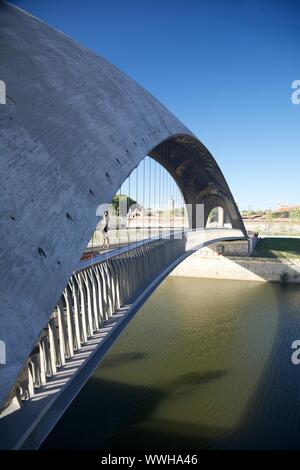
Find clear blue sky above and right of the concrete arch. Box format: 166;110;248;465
12;0;300;209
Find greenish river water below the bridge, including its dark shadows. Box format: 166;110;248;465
43;277;300;449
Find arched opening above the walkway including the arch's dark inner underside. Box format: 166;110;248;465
81;134;246;259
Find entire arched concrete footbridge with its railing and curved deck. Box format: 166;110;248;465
0;3;247;448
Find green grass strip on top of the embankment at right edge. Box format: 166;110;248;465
254;237;300;259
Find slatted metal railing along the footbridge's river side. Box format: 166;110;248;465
16;236;186;400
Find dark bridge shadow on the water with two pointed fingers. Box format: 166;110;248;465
41;370;228;449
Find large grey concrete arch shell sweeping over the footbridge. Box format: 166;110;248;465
0;2;244;406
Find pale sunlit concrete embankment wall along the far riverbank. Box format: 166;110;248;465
171;247;300;283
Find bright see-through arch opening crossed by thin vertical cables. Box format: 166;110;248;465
81;155;189;260
